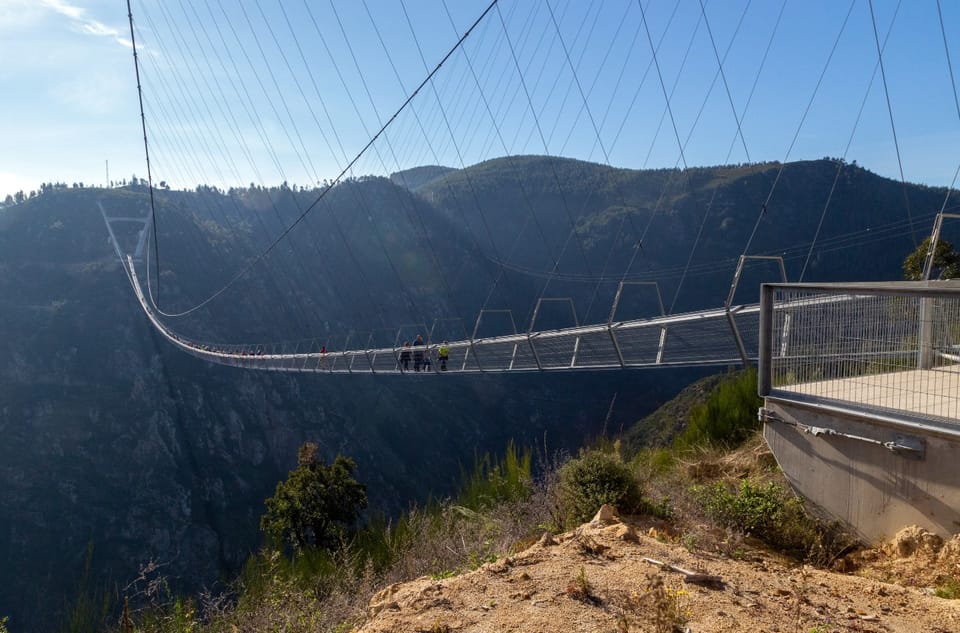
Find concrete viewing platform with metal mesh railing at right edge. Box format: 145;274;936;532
759;281;960;542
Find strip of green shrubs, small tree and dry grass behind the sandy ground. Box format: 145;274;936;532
77;373;864;633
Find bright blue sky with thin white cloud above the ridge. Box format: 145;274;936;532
0;0;960;196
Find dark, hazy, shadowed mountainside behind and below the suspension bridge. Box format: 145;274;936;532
0;160;942;630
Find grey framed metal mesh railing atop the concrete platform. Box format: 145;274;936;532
760;282;960;424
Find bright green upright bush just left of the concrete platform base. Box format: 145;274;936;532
674;369;761;450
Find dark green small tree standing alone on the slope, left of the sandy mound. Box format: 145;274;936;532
260;442;367;550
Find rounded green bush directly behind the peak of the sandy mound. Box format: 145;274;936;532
560;450;642;526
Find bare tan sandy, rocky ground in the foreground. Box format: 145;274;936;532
357;509;960;633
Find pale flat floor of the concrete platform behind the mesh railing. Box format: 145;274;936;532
777;365;960;422
